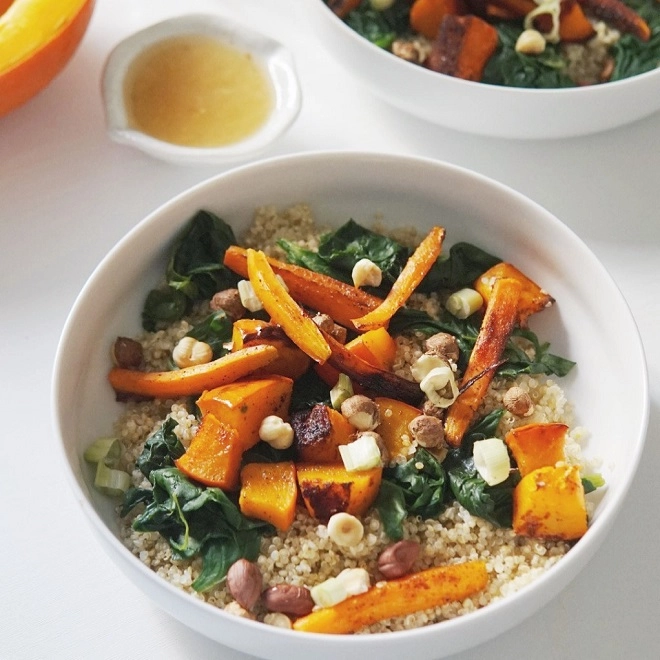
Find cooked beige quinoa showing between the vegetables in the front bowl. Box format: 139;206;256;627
115;204;587;633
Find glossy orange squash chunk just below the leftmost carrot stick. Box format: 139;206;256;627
197;374;293;451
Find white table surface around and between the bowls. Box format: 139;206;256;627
0;0;660;660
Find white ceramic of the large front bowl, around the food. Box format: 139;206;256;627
53;152;649;660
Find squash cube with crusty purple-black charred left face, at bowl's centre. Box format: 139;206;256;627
291;403;355;463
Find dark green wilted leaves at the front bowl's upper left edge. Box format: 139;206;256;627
142;210;237;331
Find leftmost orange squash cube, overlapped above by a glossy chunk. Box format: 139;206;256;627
174;414;243;490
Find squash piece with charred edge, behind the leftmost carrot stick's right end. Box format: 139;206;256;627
232;319;311;380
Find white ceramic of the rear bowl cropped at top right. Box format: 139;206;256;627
305;0;660;139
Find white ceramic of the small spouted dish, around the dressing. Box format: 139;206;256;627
102;14;302;164
